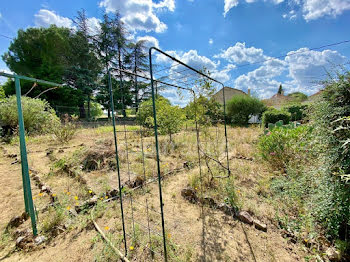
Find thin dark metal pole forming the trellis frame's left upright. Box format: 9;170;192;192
107;69;128;256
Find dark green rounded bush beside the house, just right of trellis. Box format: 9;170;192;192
227;95;266;125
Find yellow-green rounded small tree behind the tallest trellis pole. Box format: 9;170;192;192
136;97;186;140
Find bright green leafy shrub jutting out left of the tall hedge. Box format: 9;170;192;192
258;126;311;169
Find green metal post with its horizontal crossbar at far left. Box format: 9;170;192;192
0;72;62;236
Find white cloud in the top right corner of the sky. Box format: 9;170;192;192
303;0;350;21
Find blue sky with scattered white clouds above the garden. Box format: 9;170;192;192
0;0;350;98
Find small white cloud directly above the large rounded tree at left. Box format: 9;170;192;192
34;9;73;28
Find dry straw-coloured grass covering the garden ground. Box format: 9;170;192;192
0;126;303;261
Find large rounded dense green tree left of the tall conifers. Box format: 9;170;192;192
2;25;84;110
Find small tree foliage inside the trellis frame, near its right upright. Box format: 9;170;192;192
185;95;223;125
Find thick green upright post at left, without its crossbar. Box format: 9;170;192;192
15;77;37;236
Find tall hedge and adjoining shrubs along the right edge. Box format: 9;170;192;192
258;73;350;258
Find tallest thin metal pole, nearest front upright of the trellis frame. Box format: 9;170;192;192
149;47;168;262
